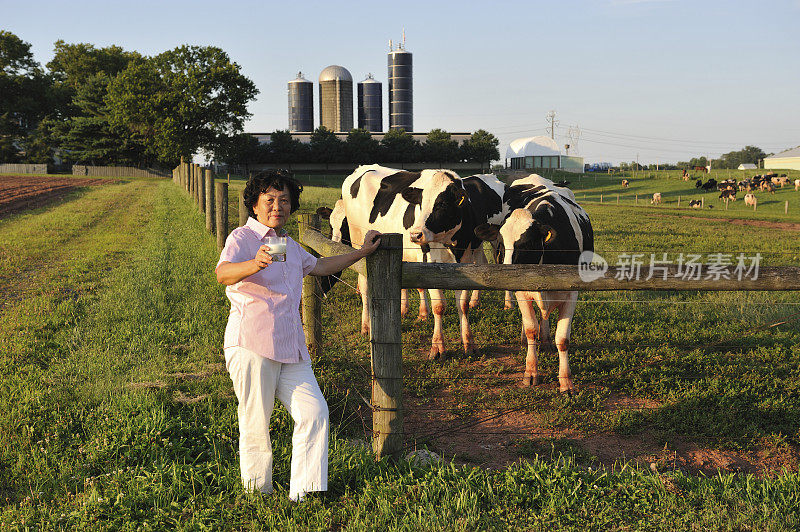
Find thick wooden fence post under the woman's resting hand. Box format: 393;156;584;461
366;233;403;460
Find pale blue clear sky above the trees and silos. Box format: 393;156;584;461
0;0;800;163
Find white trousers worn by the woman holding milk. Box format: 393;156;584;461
225;347;328;498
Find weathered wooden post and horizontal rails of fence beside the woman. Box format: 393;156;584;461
299;227;800;459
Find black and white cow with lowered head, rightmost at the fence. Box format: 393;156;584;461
476;174;594;393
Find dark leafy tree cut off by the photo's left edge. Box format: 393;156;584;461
0;30;50;161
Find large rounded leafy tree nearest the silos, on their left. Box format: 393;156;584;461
106;46;258;164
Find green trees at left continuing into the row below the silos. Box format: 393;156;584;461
0;30;499;167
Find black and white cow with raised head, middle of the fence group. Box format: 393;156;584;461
403;170;511;358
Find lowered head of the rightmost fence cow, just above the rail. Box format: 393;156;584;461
475;209;557;264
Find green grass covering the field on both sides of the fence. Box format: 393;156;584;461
0;176;800;530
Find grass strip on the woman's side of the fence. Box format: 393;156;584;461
0;182;800;530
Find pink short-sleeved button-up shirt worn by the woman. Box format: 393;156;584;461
217;217;317;363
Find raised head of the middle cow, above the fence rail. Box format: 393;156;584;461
402;170;469;244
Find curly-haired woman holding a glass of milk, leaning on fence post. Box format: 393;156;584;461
216;171;379;501
